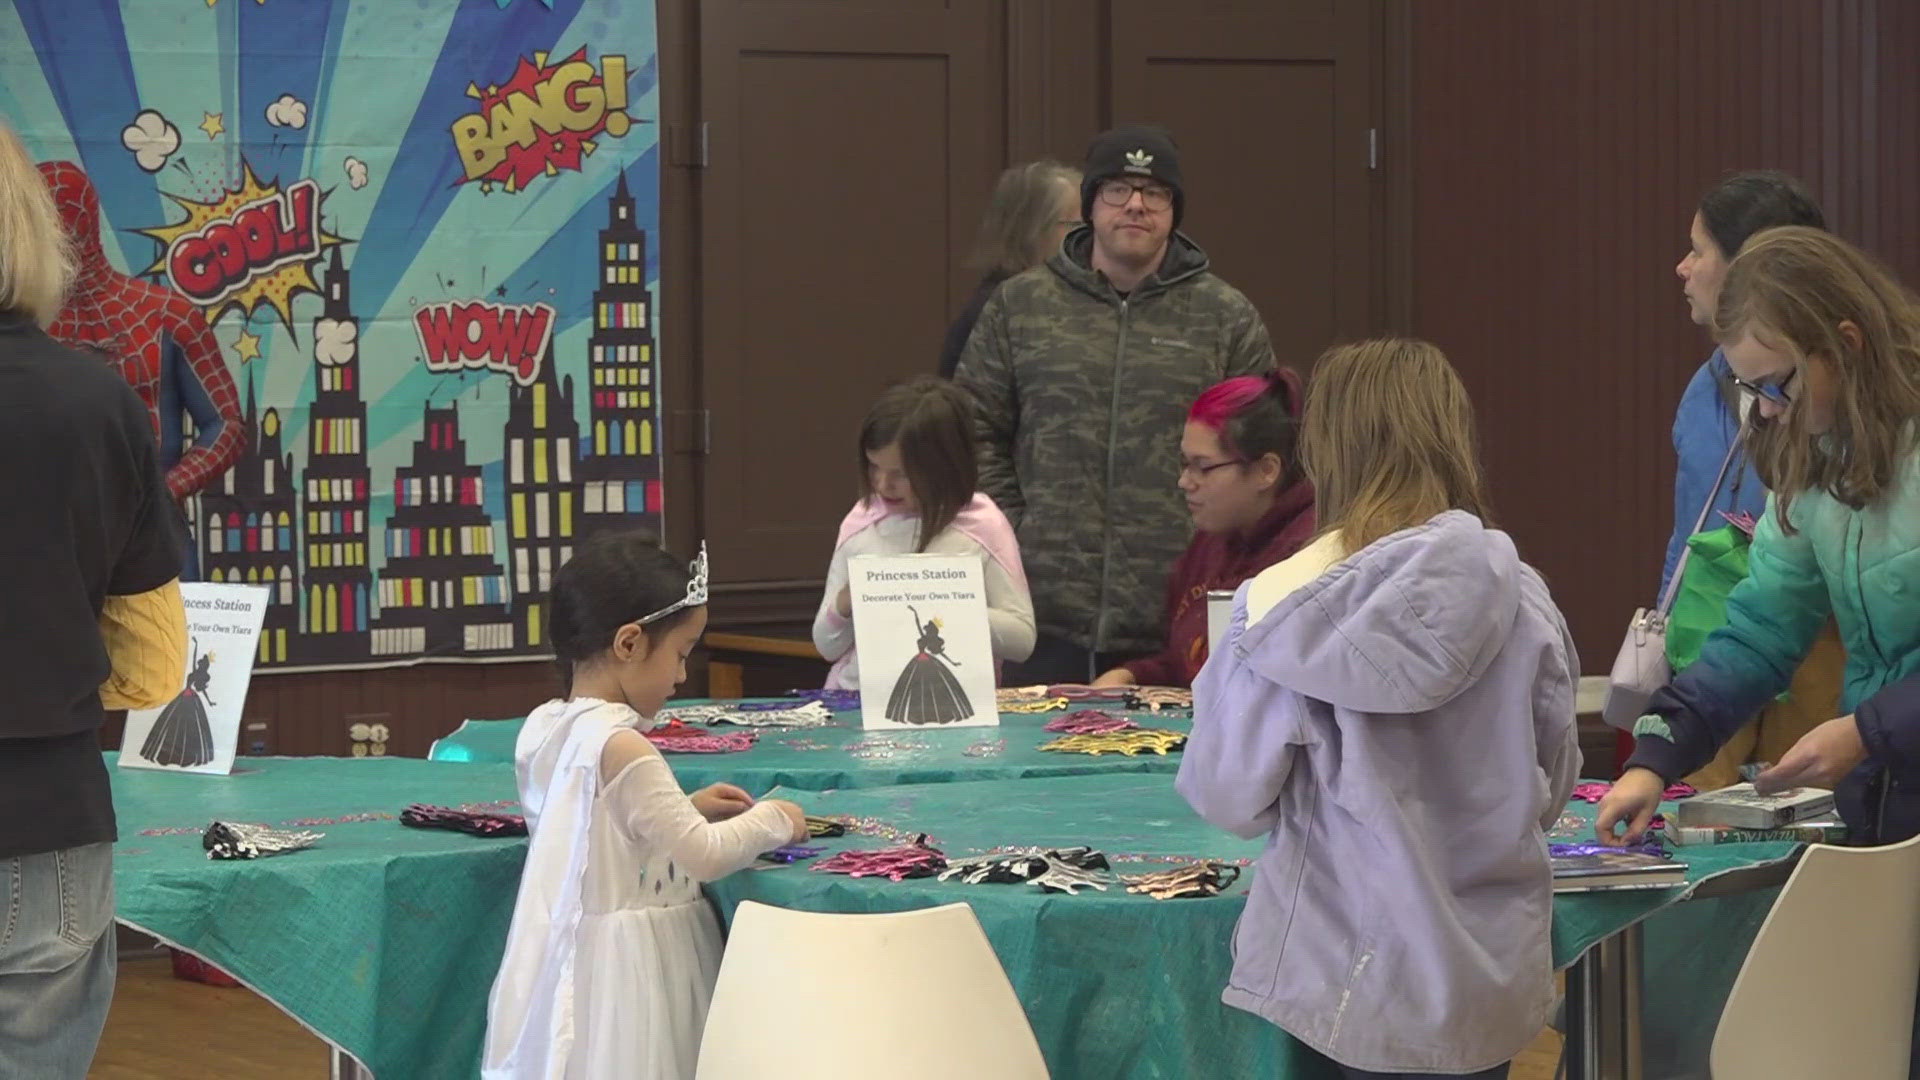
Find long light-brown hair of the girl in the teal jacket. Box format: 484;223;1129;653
1713;225;1920;532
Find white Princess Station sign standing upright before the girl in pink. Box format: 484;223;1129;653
847;555;1000;728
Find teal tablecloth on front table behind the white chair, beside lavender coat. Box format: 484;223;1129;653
708;776;1793;1080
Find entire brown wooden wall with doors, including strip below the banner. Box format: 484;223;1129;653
198;0;1920;753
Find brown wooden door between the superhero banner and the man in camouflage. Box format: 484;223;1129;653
699;0;1006;591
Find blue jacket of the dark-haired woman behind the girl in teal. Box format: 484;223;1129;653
1657;350;1766;596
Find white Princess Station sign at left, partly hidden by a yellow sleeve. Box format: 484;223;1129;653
119;582;271;774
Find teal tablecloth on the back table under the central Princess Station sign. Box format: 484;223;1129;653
432;699;1192;796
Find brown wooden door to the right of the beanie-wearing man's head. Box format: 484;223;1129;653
1108;0;1379;365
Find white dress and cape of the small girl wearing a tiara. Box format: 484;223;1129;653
482;698;791;1080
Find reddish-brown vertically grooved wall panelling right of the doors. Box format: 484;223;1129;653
1400;0;1920;673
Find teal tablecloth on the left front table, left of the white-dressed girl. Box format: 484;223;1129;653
108;755;526;1080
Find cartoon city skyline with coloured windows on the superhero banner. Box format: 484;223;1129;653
190;173;662;667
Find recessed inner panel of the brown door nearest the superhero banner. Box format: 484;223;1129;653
712;54;950;522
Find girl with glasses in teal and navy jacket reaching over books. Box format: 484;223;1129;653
1597;227;1920;844
